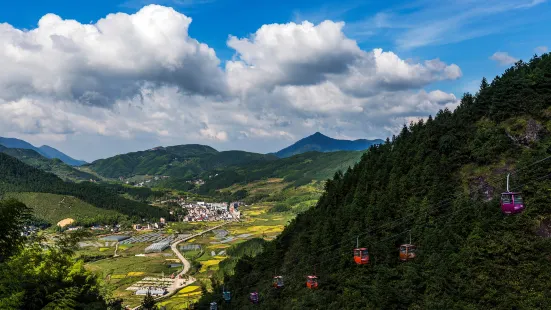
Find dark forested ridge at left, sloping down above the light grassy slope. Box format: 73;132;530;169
0;153;168;220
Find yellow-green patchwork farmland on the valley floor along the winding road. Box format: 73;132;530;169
79;179;321;309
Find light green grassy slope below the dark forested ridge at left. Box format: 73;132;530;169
5;193;123;225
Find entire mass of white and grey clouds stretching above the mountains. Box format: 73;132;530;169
0;5;462;159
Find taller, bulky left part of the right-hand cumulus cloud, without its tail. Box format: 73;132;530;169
226;21;362;91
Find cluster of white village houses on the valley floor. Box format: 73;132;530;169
180;201;241;222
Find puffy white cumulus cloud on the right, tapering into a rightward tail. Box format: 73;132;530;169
226;21;462;96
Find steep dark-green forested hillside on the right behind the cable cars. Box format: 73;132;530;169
200;54;551;309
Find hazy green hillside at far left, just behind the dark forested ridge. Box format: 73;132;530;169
0;145;99;181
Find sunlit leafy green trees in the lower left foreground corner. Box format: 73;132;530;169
0;200;122;310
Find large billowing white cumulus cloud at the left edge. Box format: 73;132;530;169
0;5;225;106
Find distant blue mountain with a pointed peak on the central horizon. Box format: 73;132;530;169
274;132;384;158
